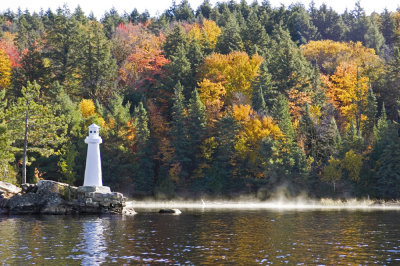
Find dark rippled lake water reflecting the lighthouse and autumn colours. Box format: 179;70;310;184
0;202;400;265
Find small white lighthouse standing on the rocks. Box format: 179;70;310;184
83;124;103;187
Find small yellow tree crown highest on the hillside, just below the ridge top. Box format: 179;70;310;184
188;19;222;49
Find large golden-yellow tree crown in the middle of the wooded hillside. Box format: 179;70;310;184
200;51;263;103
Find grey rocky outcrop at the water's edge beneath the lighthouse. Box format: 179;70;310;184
0;180;135;215
